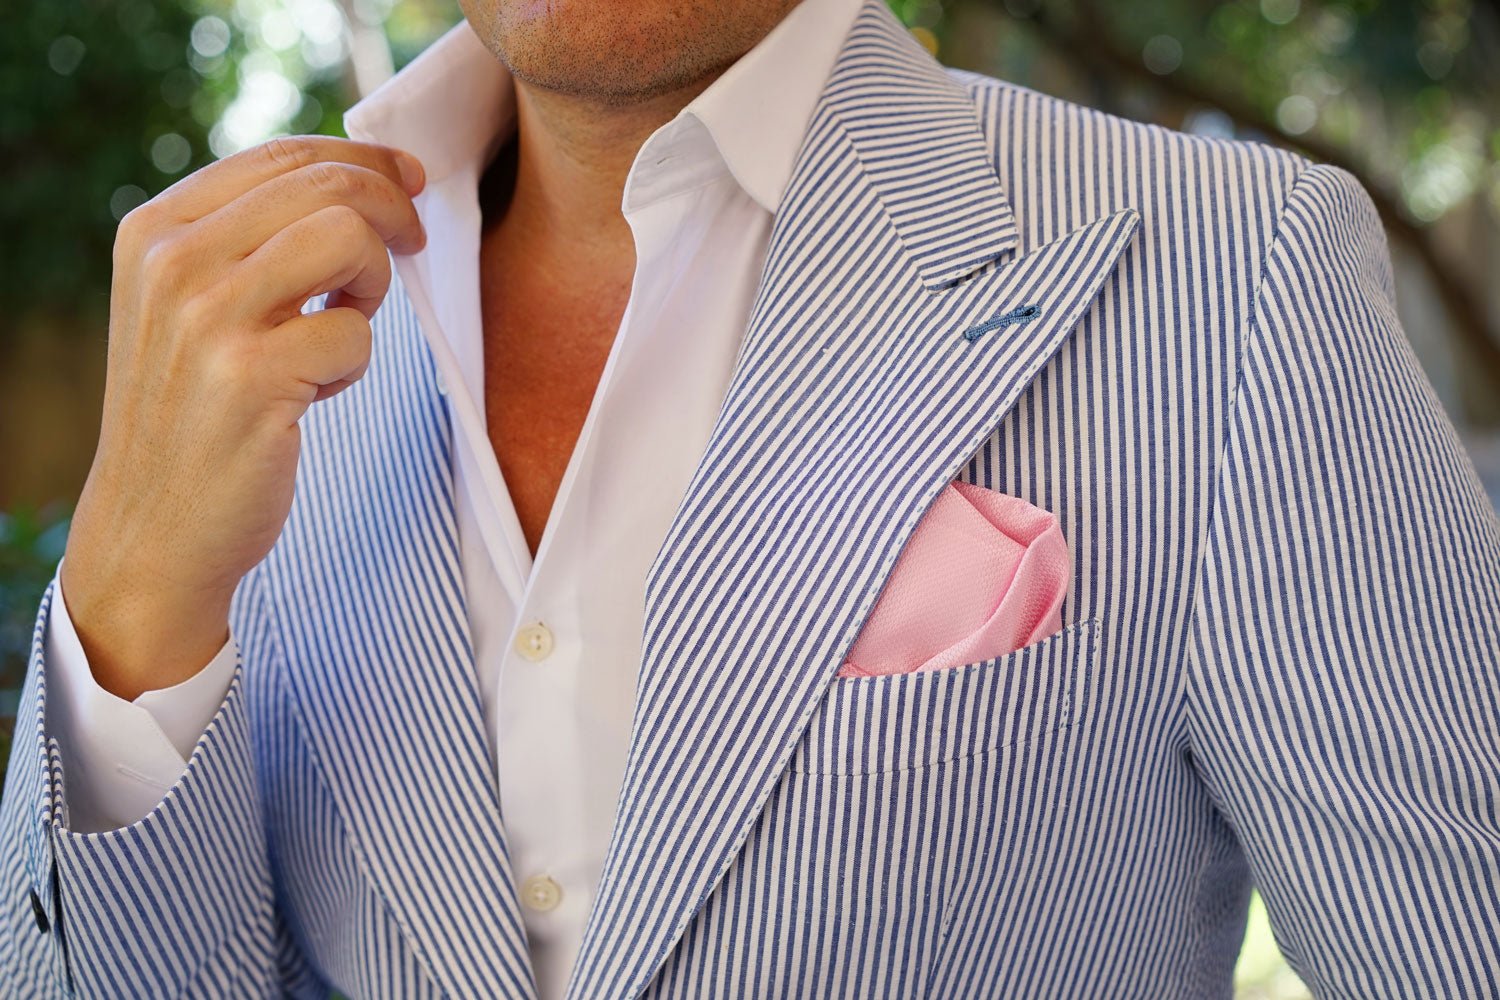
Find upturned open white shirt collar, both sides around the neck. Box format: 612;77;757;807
344;0;863;213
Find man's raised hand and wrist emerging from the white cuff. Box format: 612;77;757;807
63;136;426;699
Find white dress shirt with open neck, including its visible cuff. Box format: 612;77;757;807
47;0;860;997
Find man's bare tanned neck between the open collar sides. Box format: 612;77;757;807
495;72;719;273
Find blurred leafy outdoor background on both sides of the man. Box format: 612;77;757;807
0;0;1500;999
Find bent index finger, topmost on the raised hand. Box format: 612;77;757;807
153;135;426;222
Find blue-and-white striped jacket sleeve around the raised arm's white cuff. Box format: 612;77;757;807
0;563;278;1000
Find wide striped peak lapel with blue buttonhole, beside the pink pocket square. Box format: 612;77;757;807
569;0;1139;1000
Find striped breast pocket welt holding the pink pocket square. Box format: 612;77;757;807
791;619;1100;777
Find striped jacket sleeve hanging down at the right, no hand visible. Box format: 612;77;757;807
1188;166;1500;997
